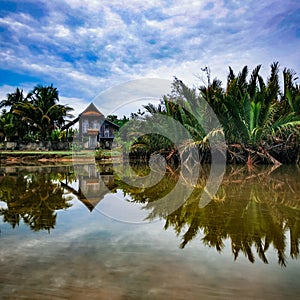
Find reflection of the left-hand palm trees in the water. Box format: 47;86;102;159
0;173;70;231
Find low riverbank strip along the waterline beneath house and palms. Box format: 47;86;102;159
0;144;300;166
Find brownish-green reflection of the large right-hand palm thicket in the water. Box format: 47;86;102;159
121;163;300;266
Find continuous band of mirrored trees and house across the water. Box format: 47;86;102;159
0;164;300;266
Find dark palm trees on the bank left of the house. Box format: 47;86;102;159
0;85;73;141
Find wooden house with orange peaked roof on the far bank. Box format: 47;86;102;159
79;103;119;148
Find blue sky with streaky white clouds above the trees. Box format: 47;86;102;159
0;0;300;115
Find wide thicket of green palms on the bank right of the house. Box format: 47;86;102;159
123;62;300;164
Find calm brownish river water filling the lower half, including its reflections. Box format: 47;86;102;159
0;165;300;299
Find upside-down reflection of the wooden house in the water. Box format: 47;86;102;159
62;164;116;211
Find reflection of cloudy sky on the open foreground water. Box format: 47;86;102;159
1;207;292;299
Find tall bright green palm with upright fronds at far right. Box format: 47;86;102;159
200;62;300;163
